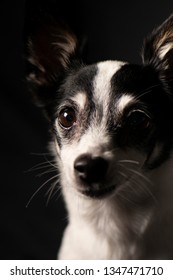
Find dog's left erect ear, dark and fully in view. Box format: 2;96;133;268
27;18;77;106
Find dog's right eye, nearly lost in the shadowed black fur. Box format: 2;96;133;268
127;110;151;130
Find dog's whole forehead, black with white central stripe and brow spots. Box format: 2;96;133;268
69;61;158;111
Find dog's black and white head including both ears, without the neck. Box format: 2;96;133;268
27;16;173;200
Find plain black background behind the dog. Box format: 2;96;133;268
0;0;173;259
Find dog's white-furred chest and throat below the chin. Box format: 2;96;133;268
59;191;148;259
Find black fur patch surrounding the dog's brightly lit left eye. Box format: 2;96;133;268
46;65;97;145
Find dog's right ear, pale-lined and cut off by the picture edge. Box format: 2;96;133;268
142;14;173;86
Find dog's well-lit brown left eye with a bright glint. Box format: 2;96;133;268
59;108;76;128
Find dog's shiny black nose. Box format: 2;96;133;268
74;154;108;184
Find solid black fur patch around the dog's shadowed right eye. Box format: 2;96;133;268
110;64;173;168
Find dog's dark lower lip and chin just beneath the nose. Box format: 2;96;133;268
79;185;116;199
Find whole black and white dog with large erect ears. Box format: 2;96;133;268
27;15;173;260
